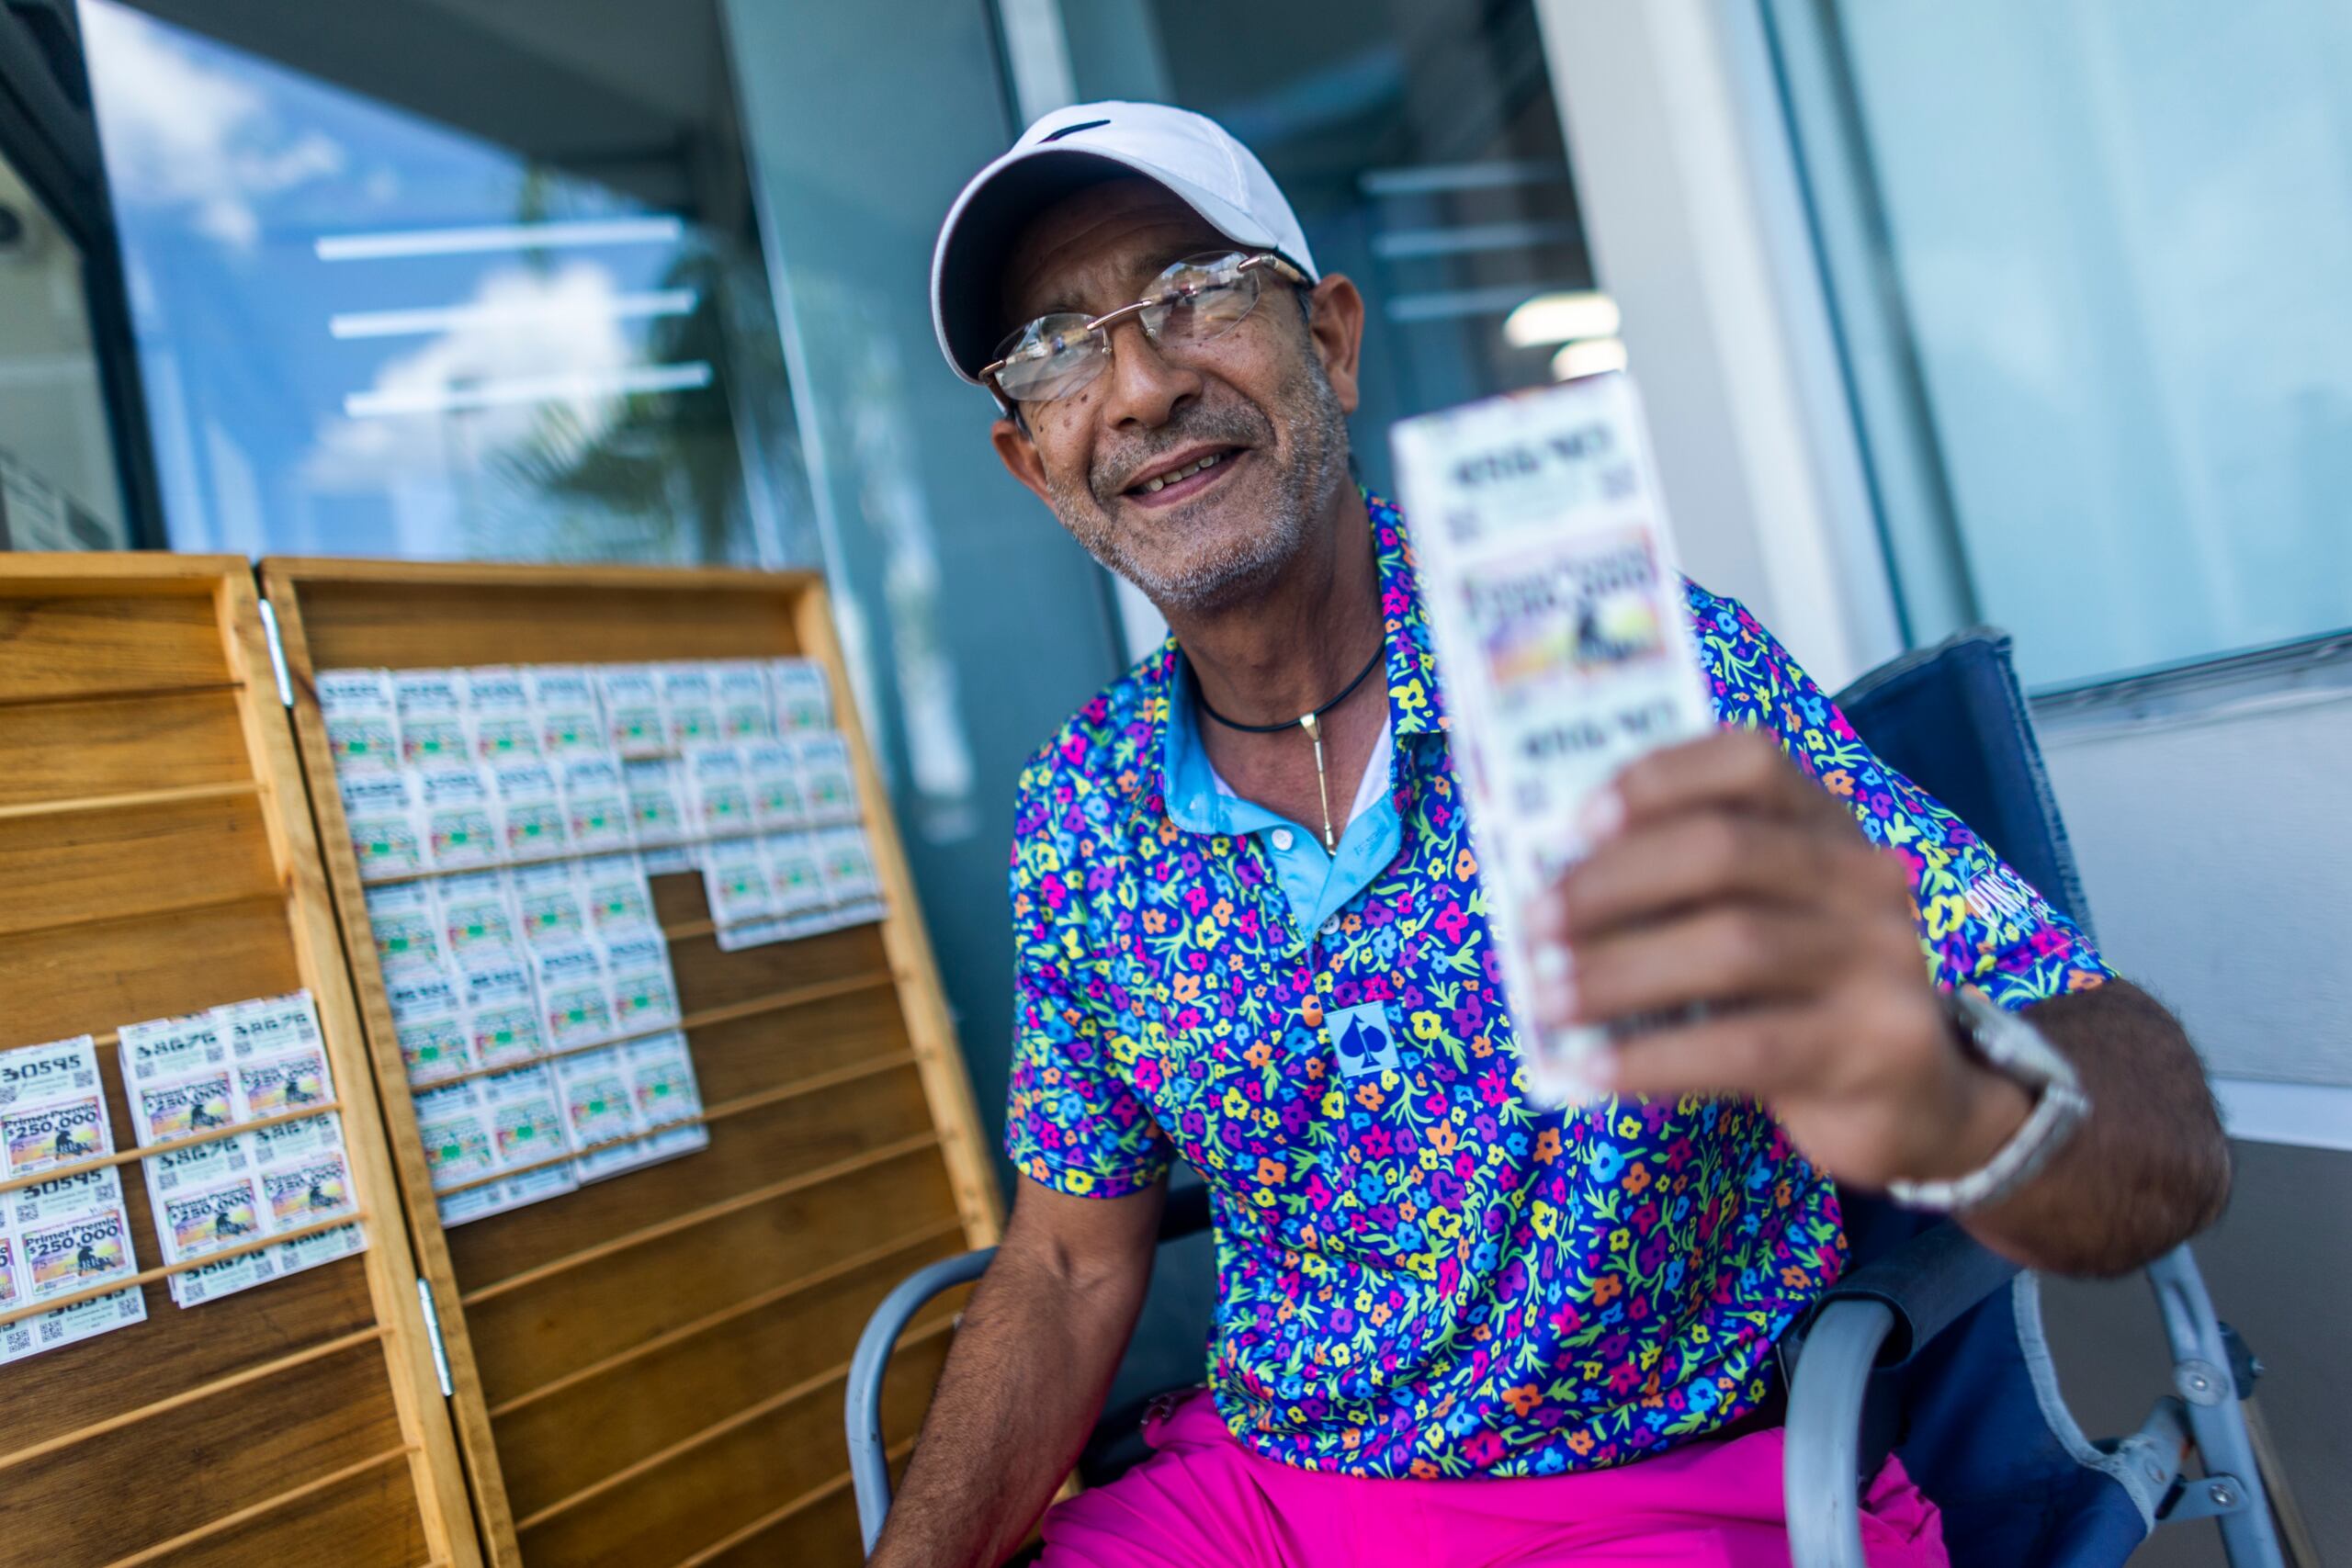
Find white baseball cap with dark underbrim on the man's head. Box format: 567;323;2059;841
932;101;1317;386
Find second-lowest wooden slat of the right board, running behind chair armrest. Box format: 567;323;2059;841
522;1333;948;1563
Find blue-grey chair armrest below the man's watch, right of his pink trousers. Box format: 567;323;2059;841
1781;1220;2018;1568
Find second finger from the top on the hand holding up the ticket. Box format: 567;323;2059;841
1536;811;1860;945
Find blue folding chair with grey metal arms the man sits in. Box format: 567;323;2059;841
847;627;2317;1568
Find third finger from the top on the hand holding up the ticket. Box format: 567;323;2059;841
1536;903;1837;1027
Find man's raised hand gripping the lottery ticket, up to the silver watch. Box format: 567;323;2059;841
1533;731;2032;1187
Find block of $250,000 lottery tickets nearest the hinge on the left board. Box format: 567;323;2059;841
122;992;367;1307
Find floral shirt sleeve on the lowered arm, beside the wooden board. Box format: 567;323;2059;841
1004;761;1173;1199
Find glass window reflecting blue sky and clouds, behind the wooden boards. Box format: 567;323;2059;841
83;0;814;562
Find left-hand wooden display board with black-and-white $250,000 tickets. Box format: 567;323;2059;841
0;552;482;1568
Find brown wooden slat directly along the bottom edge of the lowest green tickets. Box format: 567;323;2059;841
449;1069;932;1291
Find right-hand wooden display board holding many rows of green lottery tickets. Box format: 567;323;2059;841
261;559;1000;1568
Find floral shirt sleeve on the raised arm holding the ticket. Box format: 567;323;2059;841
1691;585;2114;1010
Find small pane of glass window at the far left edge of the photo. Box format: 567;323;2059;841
0;145;127;550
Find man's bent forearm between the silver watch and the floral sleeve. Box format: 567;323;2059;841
1962;980;2230;1277
